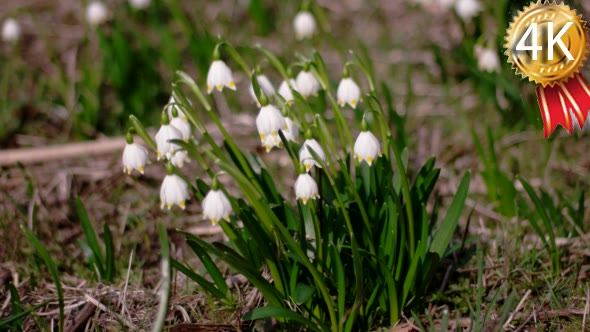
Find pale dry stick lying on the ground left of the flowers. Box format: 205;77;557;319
0;137;125;166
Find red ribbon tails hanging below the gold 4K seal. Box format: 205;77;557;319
537;73;590;138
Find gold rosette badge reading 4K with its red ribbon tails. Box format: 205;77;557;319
504;1;590;138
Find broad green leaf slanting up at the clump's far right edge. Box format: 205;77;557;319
430;172;471;258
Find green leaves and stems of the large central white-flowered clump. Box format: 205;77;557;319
131;42;470;331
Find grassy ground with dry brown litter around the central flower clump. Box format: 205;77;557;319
0;0;590;331
